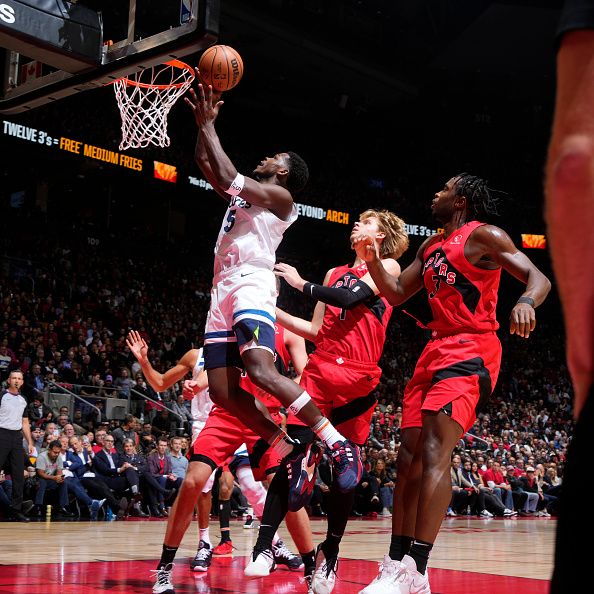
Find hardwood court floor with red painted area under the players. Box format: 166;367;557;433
0;518;556;594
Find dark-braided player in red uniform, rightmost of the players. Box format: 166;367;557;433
354;173;551;594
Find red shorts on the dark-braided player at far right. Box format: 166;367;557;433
401;332;501;432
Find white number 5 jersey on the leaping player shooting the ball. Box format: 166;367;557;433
214;196;297;275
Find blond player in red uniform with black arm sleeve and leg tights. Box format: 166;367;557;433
245;210;408;594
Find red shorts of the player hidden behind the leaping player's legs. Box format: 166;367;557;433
193;406;281;481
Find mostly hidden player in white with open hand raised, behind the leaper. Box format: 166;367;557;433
126;330;215;545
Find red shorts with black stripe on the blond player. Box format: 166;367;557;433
287;351;382;445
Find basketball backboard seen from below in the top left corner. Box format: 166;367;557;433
0;0;220;114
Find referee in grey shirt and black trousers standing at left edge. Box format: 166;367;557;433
0;369;35;522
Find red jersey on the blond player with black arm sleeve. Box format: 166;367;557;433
315;263;392;364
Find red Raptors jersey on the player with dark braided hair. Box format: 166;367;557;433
423;221;501;334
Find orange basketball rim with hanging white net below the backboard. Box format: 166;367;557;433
113;60;194;151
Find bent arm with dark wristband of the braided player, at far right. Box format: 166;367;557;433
470;225;551;338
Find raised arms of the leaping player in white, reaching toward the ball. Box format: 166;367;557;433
185;78;293;220
